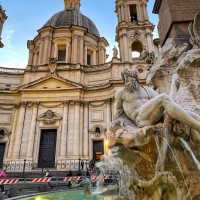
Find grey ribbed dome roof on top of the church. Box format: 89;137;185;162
43;9;100;37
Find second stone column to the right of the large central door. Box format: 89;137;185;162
73;101;80;158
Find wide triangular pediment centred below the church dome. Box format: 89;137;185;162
19;75;83;90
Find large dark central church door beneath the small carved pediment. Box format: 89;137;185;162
38;129;57;168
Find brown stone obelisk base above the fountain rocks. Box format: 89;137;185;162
154;0;200;45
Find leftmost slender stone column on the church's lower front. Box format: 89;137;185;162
8;105;19;158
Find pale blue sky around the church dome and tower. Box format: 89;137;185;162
0;0;158;68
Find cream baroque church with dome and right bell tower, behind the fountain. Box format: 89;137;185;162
0;0;160;171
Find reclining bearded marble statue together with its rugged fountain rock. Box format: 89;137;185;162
108;10;200;200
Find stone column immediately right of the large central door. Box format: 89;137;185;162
60;101;69;158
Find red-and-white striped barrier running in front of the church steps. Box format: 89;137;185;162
0;175;118;197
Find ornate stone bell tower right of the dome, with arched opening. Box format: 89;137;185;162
115;0;157;63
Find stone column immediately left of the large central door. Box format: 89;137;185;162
26;102;39;159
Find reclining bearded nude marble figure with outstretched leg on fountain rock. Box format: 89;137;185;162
114;69;200;132
